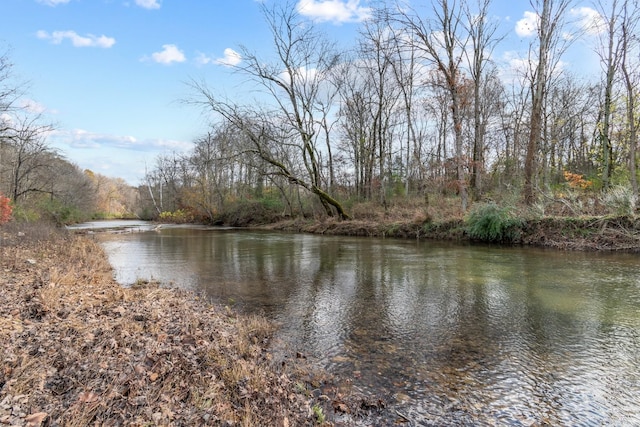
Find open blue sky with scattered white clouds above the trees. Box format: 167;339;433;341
0;0;597;185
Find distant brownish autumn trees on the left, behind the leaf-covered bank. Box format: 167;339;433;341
0;52;139;224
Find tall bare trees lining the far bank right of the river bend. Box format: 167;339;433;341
146;0;640;224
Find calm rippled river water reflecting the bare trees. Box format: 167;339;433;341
94;227;640;426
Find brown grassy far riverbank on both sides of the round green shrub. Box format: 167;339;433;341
261;216;640;252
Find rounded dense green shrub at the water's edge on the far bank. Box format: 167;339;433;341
465;202;522;243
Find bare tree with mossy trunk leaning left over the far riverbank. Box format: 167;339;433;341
192;2;348;218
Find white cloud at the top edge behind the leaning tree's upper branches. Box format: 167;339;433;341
296;0;371;23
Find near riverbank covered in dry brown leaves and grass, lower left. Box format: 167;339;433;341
0;225;360;426
